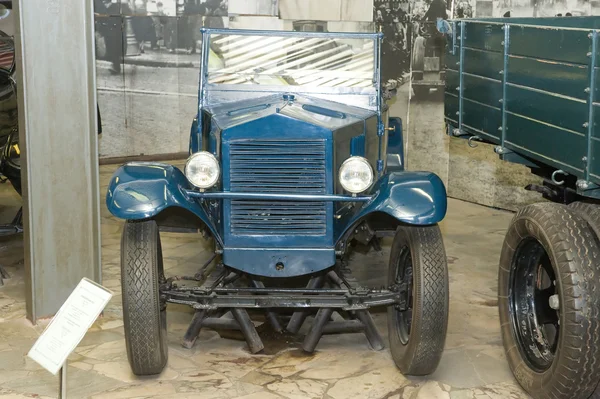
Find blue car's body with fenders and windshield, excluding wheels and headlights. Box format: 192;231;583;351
107;30;446;277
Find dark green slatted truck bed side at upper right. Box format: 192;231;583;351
445;17;600;197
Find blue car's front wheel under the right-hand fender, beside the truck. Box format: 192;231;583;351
388;225;448;375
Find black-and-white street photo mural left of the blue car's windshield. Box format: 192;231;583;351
94;0;229;158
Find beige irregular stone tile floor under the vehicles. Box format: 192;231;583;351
0;165;528;399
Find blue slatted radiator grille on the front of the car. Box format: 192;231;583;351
229;139;327;235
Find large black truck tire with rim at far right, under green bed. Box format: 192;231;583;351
498;203;600;399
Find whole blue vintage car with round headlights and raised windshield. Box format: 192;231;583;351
107;30;448;375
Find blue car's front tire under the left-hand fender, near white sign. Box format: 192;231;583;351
121;220;168;375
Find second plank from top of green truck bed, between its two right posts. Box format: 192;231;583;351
507;56;588;100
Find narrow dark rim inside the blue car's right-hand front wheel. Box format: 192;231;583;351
395;247;413;345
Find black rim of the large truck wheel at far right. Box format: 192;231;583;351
509;237;560;372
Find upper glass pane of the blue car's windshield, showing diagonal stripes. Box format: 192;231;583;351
208;34;375;87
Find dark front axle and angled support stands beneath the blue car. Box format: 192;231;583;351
160;264;412;353
